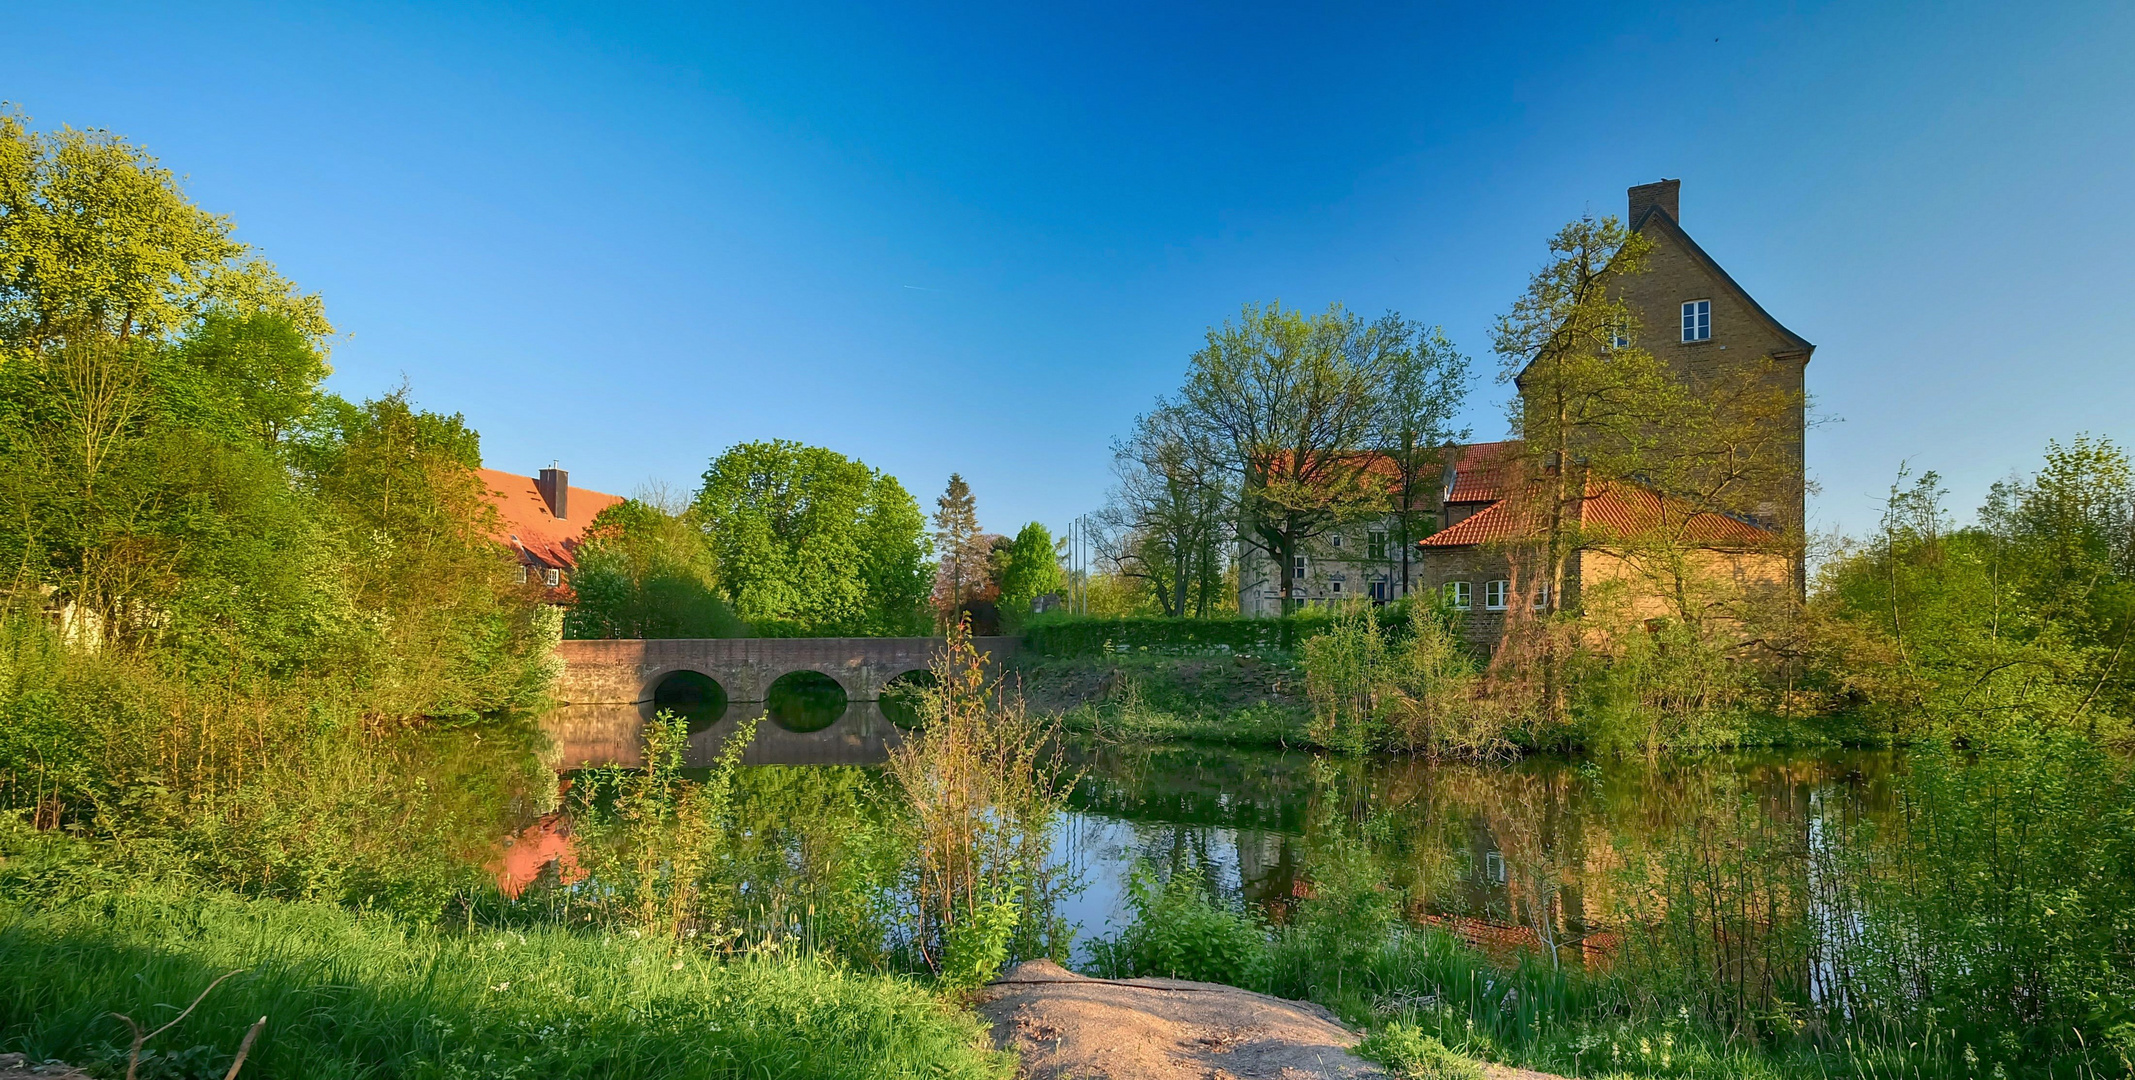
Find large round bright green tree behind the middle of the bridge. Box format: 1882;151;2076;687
692;440;927;634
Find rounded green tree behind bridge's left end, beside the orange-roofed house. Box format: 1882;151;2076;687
564;499;747;638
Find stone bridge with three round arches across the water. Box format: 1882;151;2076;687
544;638;1023;768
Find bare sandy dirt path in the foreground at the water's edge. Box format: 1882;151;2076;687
978;960;1559;1080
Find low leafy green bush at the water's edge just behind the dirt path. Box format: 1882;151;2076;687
1091;867;1268;986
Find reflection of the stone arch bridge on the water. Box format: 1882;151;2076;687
542;700;903;771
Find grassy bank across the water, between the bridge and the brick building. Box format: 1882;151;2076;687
1012;651;1313;747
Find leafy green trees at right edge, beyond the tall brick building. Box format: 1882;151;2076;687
1810;440;2135;743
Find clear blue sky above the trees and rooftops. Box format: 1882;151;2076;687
0;2;2135;546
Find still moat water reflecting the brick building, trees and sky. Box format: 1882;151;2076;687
542;702;1894;963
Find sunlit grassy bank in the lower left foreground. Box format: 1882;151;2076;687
0;892;1012;1080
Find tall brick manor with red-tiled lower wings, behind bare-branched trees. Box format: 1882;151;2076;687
1238;179;1815;640
